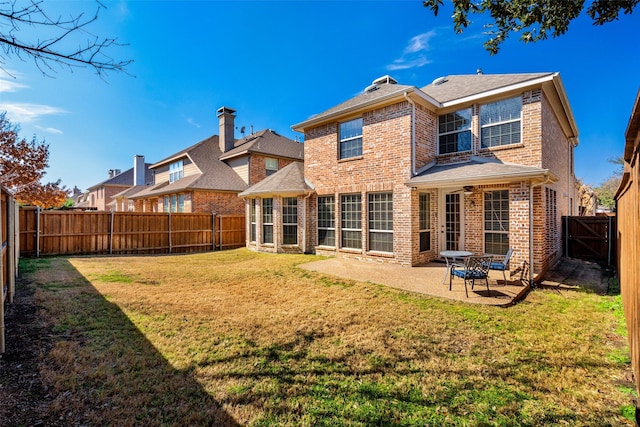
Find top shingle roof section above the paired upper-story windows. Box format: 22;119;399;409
420;73;554;103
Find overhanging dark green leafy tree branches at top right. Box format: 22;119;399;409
422;0;640;55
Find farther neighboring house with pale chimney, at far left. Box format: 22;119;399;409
84;155;153;211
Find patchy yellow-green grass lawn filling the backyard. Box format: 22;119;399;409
21;249;636;426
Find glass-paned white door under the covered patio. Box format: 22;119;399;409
438;189;464;251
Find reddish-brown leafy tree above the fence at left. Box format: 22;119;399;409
0;112;68;208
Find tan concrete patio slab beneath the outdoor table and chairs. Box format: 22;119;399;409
299;258;529;306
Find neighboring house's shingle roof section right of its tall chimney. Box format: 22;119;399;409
220;129;304;160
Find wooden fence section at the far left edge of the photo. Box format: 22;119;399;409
0;187;18;353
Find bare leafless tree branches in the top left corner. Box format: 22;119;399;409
0;0;132;77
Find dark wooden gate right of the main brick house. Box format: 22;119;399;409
562;216;616;266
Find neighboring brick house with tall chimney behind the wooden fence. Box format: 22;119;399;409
126;107;304;215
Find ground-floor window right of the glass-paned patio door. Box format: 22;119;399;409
484;190;509;255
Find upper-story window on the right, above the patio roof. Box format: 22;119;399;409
480;98;522;148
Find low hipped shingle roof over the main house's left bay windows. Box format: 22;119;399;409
238;162;313;197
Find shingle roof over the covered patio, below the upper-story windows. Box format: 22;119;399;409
406;157;556;188
